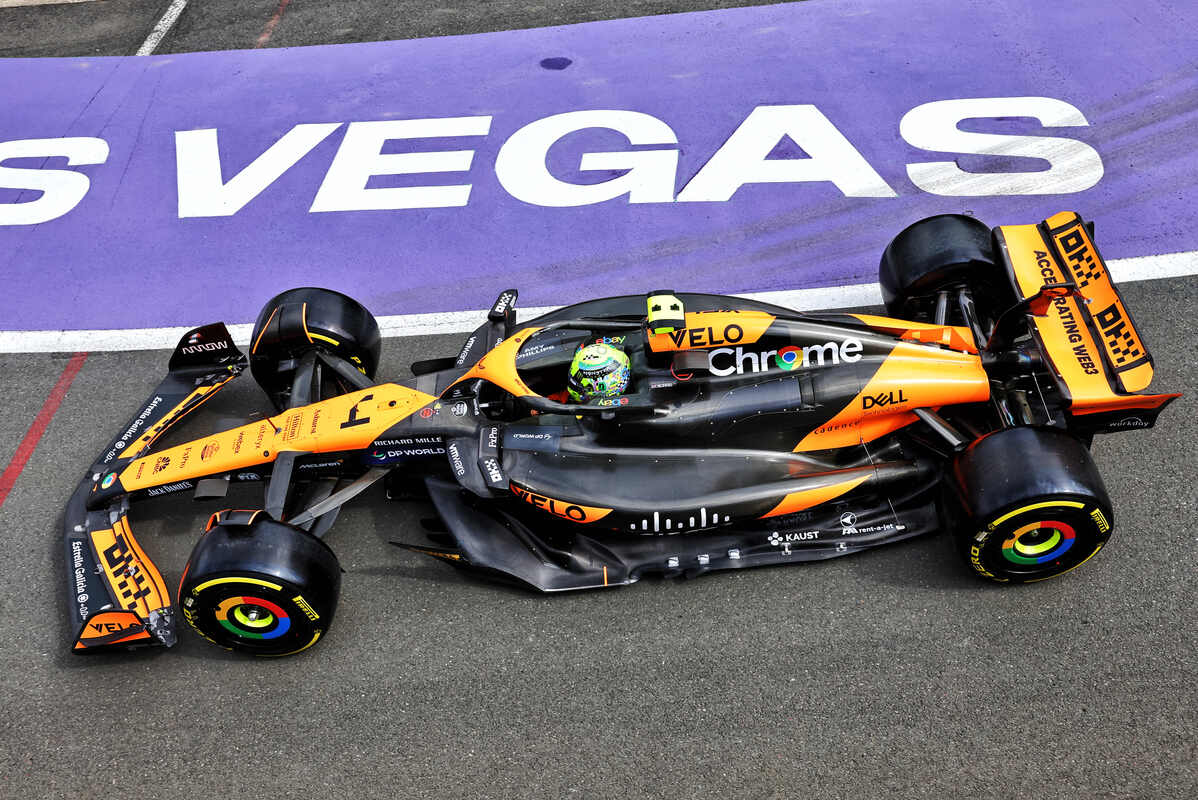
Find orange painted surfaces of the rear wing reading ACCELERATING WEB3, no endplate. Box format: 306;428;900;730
999;212;1152;413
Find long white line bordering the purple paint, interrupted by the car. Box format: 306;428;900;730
0;250;1198;353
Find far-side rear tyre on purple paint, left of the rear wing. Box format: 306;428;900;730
878;214;1015;323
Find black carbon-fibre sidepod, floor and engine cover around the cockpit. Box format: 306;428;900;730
377;295;963;592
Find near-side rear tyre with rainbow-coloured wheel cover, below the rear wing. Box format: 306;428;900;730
952;428;1114;583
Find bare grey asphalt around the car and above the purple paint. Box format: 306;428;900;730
0;0;1198;798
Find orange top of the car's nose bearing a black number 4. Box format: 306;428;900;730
120;383;436;491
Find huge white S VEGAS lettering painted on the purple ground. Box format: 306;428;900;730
0;97;1103;225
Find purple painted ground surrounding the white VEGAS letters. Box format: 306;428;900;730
0;0;1198;329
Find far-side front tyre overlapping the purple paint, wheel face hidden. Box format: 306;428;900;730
249;286;382;411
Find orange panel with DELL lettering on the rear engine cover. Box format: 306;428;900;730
794;341;990;453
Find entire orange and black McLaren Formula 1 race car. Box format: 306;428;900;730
65;213;1179;655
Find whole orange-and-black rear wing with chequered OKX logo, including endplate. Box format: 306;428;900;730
994;211;1180;430
